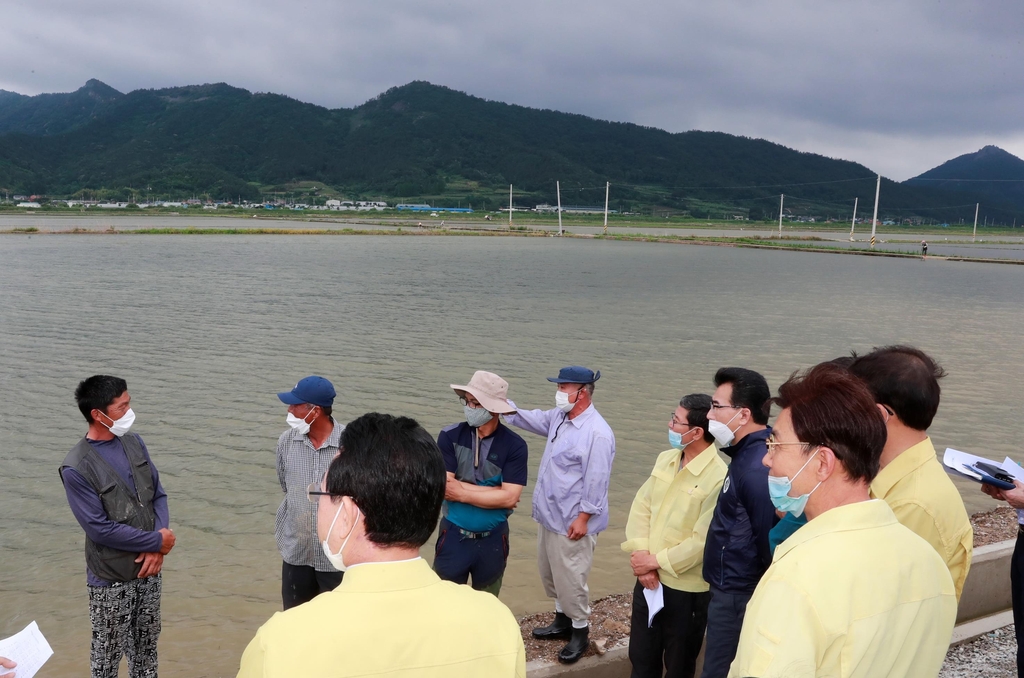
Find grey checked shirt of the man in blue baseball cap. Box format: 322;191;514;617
274;422;345;573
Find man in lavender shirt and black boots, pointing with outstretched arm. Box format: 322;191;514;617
505;366;615;664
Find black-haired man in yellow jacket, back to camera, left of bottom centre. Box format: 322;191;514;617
238;413;526;678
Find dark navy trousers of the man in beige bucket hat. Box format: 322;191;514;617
434;518;509;596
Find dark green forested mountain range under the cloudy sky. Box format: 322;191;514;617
0;80;1024;223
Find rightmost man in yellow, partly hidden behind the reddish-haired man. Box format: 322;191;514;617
850;346;974;602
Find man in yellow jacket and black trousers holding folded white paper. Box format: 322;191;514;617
623;393;728;678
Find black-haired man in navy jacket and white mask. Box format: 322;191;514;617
701;368;778;678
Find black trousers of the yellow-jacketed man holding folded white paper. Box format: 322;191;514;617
630;582;711;678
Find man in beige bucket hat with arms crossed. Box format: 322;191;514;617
434;371;526;596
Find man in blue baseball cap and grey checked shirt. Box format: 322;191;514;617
274;377;344;609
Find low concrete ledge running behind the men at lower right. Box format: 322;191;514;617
526;540;1016;678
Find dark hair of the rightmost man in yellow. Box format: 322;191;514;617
850;345;946;431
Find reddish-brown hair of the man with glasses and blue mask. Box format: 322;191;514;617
774;362;886;483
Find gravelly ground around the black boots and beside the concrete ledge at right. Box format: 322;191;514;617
519;506;1017;663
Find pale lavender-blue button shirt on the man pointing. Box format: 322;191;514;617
505;400;615;535
